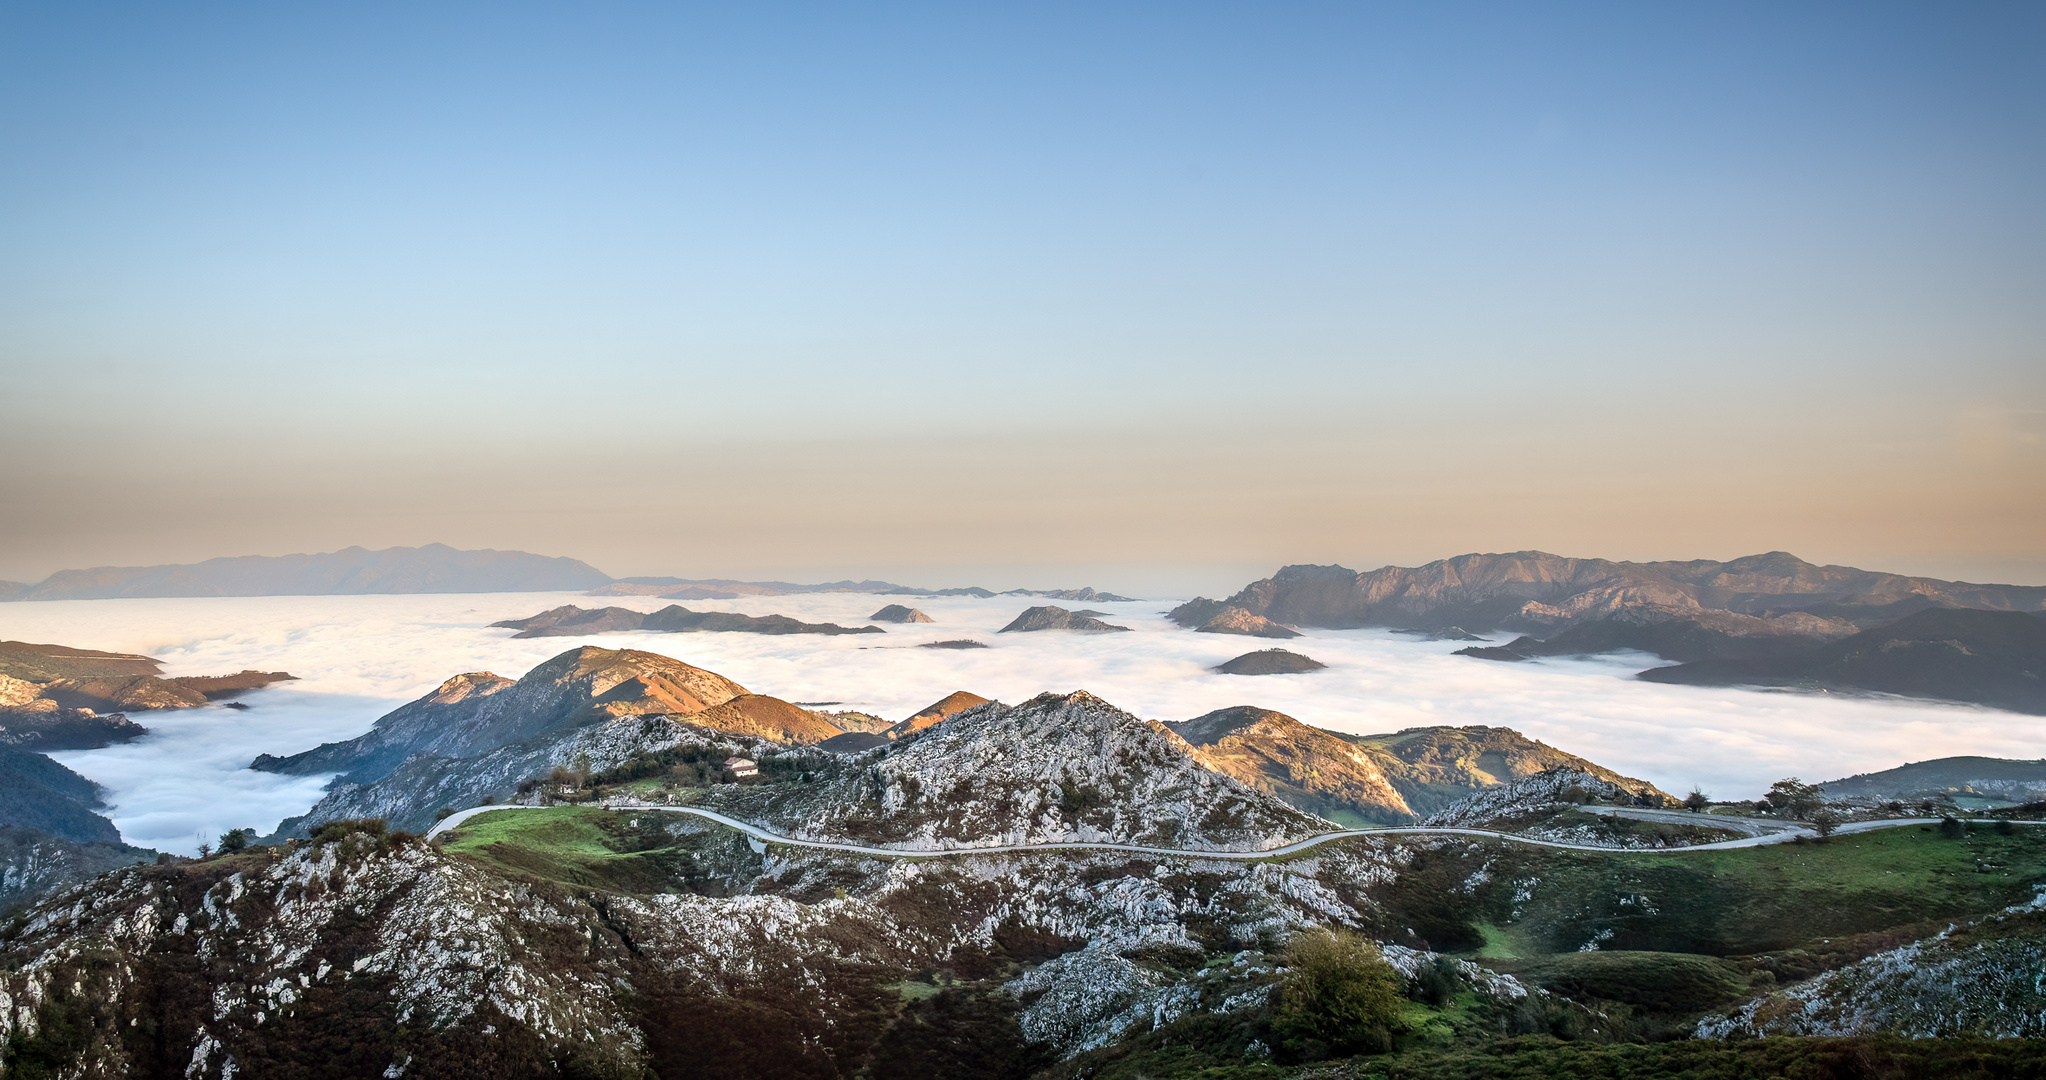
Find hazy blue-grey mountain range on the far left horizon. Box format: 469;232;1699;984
0;544;610;599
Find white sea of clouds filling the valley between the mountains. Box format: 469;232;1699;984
0;593;2046;853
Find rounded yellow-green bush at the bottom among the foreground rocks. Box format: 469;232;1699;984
1273;931;1406;1053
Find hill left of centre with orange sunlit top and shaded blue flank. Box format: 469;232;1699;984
250;646;749;783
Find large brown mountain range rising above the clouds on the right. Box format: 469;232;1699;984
1170;552;2046;712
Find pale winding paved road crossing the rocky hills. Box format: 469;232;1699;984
428;800;2046;861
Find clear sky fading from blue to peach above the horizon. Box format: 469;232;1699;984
0;2;2046;593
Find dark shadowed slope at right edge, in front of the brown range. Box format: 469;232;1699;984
1641;610;2046;714
